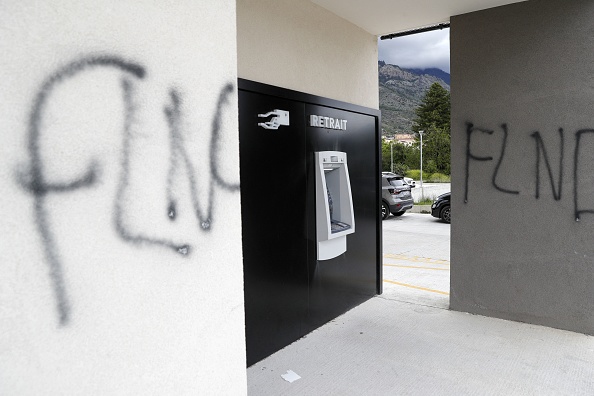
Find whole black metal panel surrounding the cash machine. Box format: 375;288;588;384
238;79;382;365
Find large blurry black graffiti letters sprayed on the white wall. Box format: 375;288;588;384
18;56;239;326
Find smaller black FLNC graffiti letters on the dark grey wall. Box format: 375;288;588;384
464;122;594;221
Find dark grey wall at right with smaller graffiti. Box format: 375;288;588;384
450;0;594;334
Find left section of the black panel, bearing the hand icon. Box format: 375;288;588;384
238;91;307;365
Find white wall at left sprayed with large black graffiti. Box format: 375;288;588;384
0;0;246;395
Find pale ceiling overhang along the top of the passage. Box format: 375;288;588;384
310;0;525;36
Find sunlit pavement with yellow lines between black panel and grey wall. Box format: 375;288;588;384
381;213;450;309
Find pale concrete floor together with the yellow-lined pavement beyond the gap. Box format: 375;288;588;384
248;213;594;396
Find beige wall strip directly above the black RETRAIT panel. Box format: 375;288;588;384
237;0;379;109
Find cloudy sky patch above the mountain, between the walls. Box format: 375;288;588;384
378;29;450;73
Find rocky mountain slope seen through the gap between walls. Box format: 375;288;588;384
378;61;450;136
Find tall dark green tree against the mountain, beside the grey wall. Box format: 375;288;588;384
412;83;450;134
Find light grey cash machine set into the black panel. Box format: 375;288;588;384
315;151;355;260
